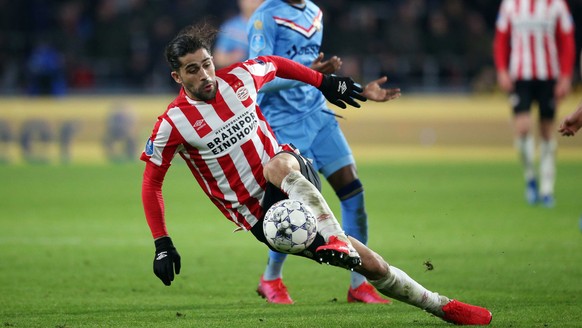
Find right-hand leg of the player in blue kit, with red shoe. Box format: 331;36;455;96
309;112;390;303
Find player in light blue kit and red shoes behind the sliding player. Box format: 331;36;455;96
248;0;400;304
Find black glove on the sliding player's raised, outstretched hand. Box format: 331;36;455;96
318;74;367;108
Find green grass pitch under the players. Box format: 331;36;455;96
0;162;582;328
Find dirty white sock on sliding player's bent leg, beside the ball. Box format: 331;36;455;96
281;171;345;242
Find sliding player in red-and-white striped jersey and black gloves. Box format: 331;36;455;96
141;25;492;325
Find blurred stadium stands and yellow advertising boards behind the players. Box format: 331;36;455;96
0;0;582;163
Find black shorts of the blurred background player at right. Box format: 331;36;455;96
511;80;556;120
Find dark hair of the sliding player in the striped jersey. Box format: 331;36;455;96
165;23;218;71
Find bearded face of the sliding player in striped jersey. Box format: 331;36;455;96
172;49;217;101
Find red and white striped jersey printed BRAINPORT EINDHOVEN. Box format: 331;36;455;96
141;56;321;238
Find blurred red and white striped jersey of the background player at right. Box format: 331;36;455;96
494;0;575;80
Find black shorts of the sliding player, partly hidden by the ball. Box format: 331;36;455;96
251;151;325;259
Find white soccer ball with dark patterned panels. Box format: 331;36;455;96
263;199;317;254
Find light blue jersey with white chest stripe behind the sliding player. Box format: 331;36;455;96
247;0;326;129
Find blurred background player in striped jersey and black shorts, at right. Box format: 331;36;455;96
493;0;575;207
